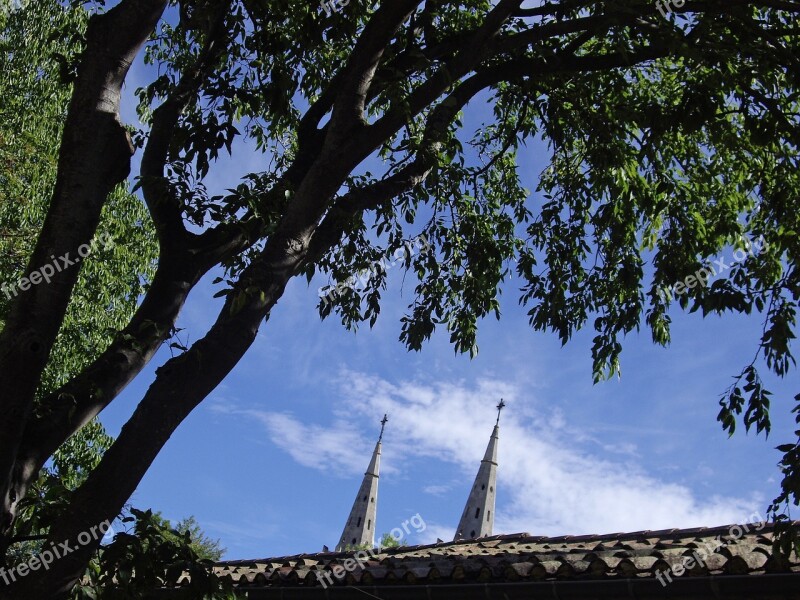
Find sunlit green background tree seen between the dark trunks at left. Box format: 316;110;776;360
0;0;156;566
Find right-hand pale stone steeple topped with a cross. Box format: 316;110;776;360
453;398;506;542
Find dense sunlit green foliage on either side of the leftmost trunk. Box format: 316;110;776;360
0;0;157;396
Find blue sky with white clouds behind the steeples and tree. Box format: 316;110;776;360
95;15;797;559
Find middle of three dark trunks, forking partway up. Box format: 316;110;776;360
3;3;261;544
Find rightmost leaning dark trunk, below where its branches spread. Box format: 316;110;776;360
7;182;344;600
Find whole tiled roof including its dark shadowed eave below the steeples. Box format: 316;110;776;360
198;525;800;600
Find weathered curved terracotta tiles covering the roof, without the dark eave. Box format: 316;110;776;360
211;526;800;597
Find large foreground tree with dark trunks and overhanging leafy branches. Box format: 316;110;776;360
0;0;800;598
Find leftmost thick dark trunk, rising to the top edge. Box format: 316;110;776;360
0;0;166;535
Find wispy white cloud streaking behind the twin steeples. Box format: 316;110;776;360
211;371;761;541
